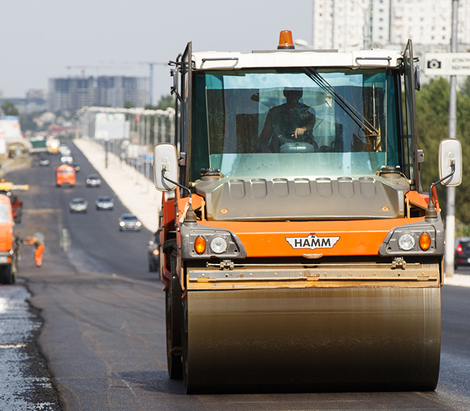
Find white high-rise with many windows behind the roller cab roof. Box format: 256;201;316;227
312;0;470;50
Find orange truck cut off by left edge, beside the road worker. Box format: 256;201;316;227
0;194;18;284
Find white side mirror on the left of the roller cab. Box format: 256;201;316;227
153;143;178;191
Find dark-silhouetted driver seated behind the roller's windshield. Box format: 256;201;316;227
259;87;317;153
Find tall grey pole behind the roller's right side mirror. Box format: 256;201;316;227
445;0;459;277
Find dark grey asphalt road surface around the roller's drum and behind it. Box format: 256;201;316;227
0;144;470;411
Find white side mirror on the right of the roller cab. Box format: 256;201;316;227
439;138;462;187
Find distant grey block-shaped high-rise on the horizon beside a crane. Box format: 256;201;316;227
48;76;149;111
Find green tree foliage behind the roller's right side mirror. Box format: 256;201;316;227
416;78;470;226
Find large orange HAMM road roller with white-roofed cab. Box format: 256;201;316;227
154;31;462;394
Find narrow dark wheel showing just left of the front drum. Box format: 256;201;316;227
165;255;183;380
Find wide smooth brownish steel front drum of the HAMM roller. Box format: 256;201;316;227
183;287;441;393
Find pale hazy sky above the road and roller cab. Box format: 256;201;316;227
0;0;312;101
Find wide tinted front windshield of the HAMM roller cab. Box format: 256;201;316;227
190;68;401;181
